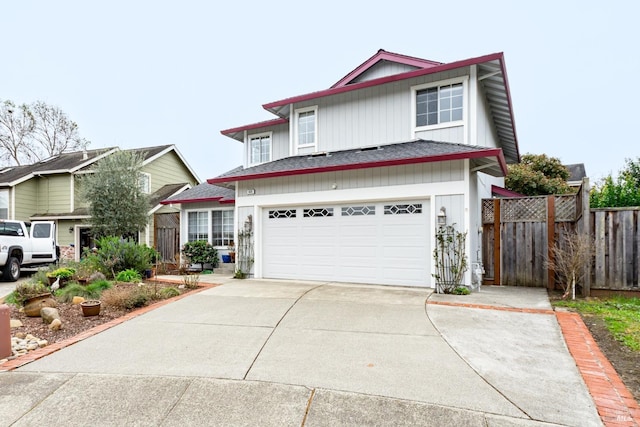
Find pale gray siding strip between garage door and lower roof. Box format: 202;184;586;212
237;160;464;198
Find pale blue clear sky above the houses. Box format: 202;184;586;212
0;0;640;181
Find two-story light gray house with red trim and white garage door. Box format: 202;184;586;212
205;50;520;286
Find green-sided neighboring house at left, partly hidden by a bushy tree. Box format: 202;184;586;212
0;145;199;259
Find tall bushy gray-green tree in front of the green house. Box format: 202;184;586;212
81;151;149;237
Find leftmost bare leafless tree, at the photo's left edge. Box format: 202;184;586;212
0;100;36;165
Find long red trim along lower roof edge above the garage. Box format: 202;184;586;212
207;148;507;184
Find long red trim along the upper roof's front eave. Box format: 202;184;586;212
262;52;504;111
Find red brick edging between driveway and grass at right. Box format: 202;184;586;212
556;311;640;427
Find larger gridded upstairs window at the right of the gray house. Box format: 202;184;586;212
415;83;464;127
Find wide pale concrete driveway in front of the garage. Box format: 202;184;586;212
0;275;601;426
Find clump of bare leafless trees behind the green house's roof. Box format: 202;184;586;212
0;100;89;165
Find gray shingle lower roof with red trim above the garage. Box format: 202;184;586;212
207;139;506;184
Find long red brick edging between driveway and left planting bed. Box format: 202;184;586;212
0;280;218;372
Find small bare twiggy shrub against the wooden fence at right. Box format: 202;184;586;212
545;231;594;299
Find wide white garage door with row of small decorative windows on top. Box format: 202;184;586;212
262;201;431;286
